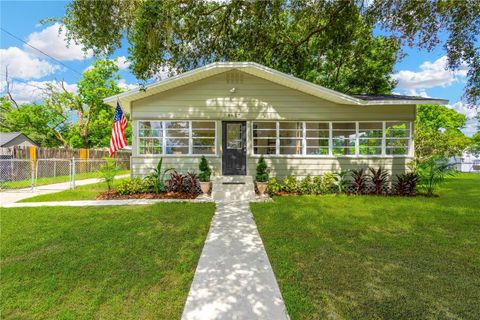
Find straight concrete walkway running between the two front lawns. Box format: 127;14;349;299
182;201;288;320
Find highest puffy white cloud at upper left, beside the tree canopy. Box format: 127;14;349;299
24;23;93;60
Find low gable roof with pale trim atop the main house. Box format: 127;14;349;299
104;62;448;110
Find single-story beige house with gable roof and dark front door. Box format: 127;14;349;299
105;62;448;177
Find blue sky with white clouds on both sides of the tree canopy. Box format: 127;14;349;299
0;0;475;135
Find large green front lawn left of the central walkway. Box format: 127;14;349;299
0;203;214;319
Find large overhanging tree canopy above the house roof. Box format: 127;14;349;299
62;0;480;105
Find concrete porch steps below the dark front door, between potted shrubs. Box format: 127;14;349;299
212;176;255;202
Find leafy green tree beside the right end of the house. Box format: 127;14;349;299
414;105;471;161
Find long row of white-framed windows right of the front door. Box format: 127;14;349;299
250;120;414;159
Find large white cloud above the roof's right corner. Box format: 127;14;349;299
392;56;467;96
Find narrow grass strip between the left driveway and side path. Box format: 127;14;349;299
18;178;129;202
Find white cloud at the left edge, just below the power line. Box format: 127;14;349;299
0;47;61;80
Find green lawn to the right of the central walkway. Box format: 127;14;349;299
251;174;480;319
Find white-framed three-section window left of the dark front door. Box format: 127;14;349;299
135;119;218;158
